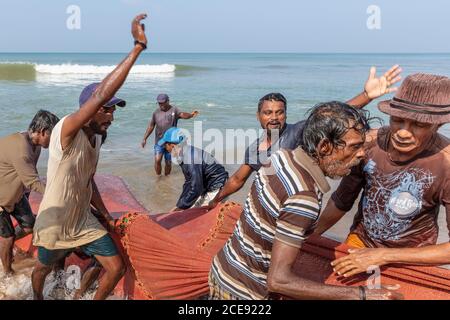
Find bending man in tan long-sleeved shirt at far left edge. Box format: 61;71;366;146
0;110;59;275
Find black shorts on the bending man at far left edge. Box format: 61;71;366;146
0;195;36;238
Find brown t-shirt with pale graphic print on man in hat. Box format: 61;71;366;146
332;127;450;247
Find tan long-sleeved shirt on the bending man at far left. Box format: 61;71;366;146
0;133;45;212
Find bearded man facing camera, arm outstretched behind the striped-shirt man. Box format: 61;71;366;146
209;65;401;208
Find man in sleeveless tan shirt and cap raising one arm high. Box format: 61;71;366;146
32;14;147;300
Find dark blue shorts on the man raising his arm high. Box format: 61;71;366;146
38;234;119;266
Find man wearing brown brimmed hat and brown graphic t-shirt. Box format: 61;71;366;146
316;74;450;277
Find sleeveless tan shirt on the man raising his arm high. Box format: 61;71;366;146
33;117;107;250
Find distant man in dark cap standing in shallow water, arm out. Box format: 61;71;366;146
141;93;198;176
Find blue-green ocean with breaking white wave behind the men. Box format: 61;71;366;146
0;52;450;300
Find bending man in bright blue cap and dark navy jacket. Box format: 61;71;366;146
158;127;228;211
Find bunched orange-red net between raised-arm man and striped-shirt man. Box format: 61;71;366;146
117;203;242;299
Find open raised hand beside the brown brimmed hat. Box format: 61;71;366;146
364;65;402;99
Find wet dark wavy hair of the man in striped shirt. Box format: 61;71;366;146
301;101;377;159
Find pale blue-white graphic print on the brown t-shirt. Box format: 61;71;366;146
363;159;435;240
